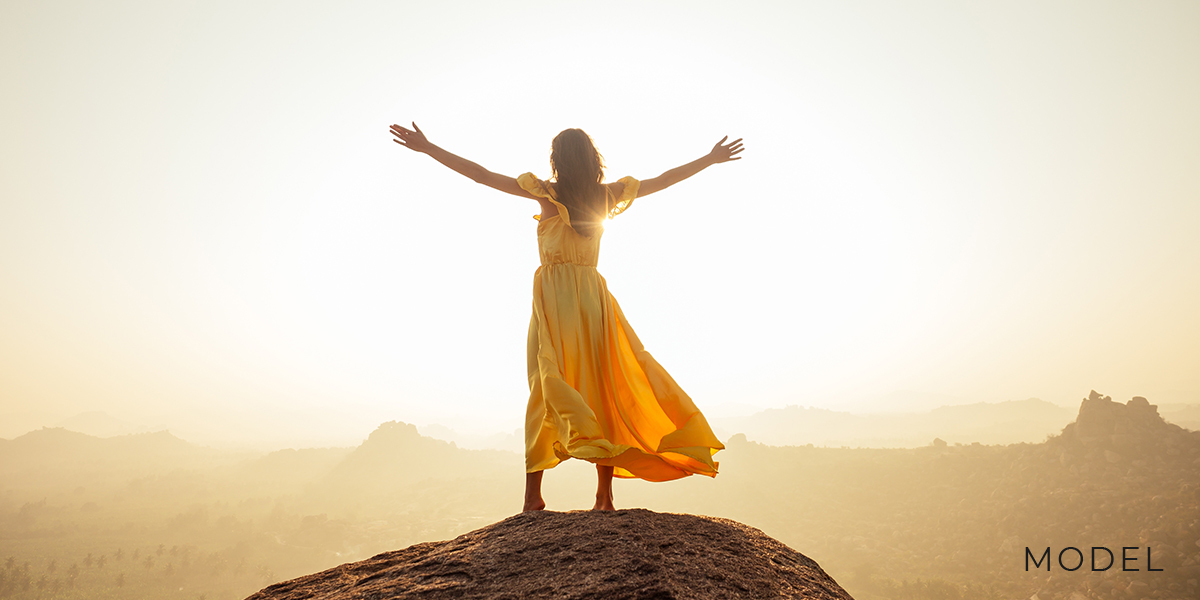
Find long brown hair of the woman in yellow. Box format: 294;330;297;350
550;128;607;236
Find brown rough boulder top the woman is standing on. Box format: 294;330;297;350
248;509;851;600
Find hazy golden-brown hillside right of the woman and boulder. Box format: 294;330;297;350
648;392;1200;600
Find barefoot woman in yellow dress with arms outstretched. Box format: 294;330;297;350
391;122;743;511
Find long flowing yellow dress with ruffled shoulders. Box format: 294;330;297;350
517;173;725;481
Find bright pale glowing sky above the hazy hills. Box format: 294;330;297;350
0;0;1200;445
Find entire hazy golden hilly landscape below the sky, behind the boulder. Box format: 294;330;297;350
0;395;1200;600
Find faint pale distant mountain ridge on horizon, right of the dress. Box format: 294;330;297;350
712;398;1074;448
